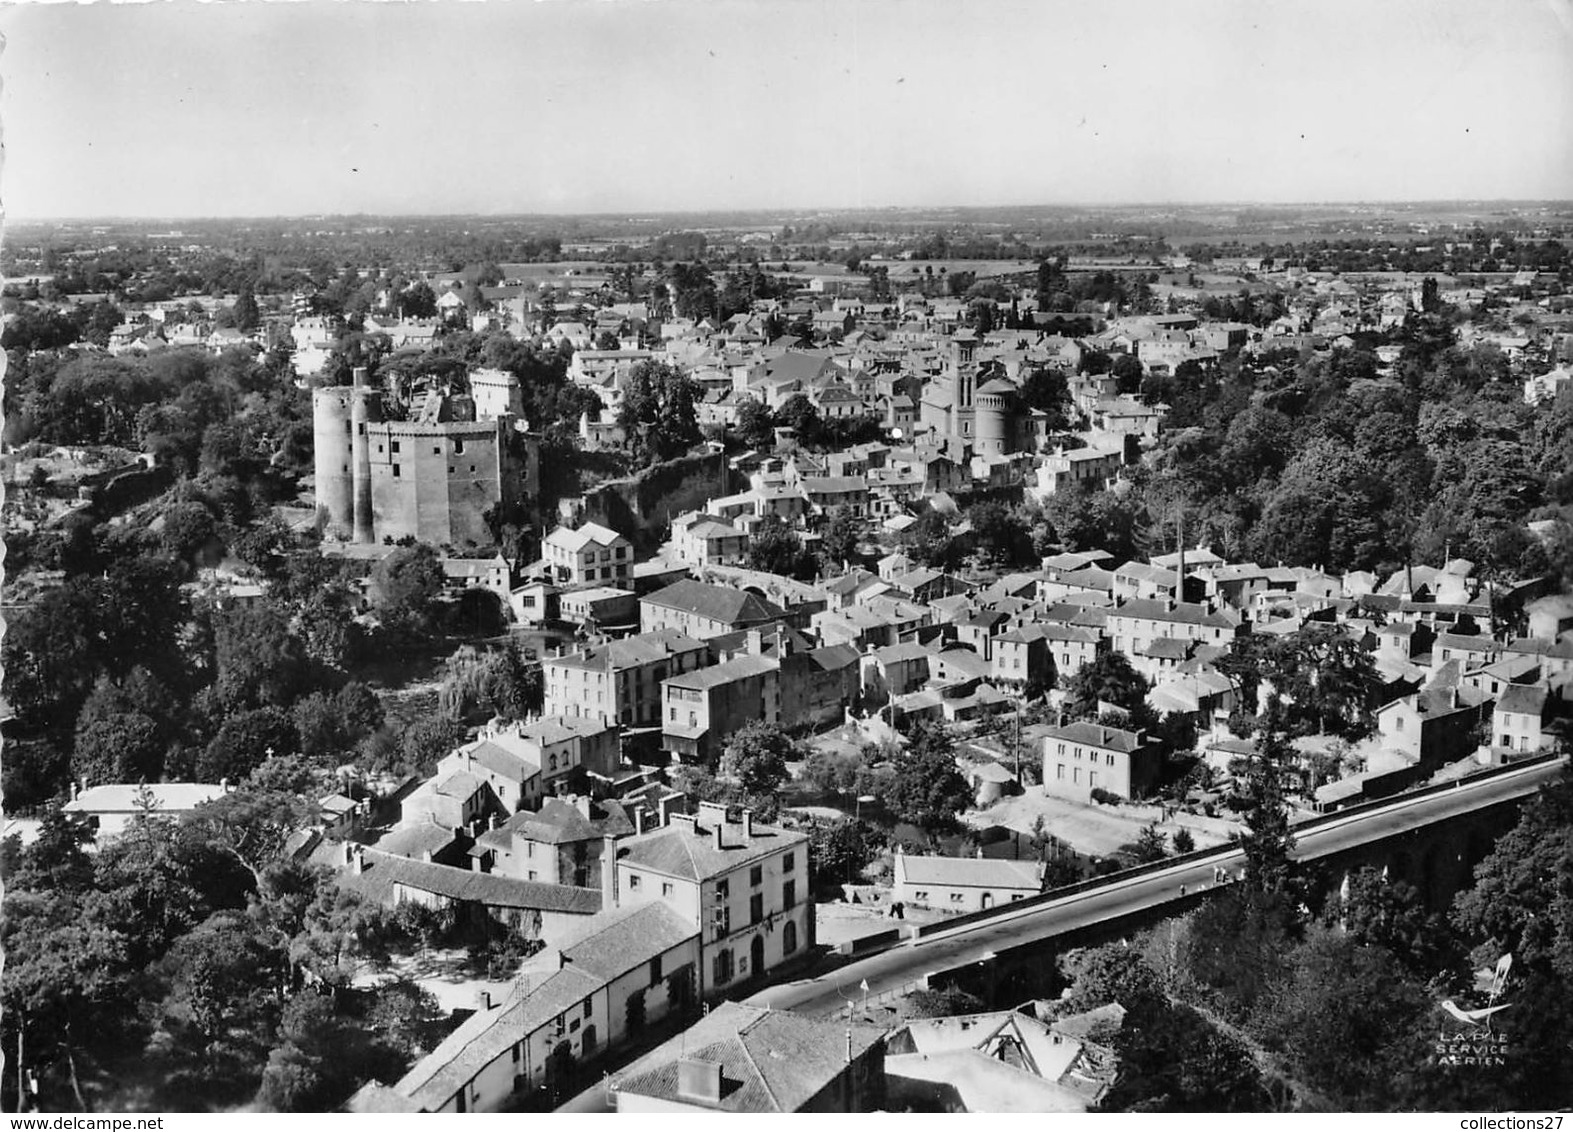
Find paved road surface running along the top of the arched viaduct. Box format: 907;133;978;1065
749;761;1562;1014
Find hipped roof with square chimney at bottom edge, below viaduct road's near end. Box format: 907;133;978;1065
612;1002;884;1113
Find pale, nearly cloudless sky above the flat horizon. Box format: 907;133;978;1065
0;0;1573;220
